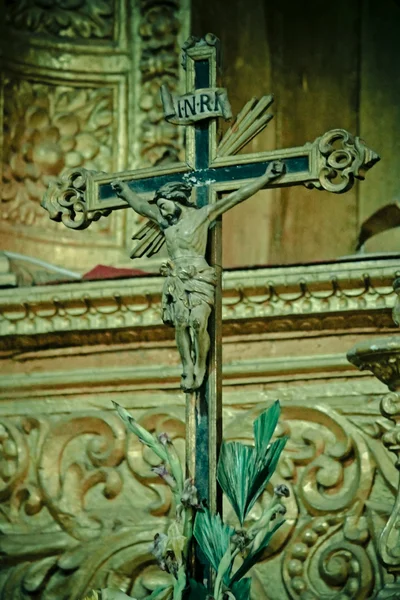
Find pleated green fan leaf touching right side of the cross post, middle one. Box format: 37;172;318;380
217;442;256;525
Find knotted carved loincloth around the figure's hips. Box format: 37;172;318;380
160;261;217;326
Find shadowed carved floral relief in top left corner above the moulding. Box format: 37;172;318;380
5;0;115;39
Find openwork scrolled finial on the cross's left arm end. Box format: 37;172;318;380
41;169;111;229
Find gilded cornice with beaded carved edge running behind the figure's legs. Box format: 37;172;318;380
0;259;398;348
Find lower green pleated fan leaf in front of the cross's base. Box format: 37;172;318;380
193;509;235;572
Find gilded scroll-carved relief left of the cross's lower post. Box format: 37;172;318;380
0;414;183;600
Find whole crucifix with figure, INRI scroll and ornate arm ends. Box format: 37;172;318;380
42;34;379;512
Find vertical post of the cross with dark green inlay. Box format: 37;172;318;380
184;34;222;512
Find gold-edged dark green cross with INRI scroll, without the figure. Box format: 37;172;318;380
43;34;379;511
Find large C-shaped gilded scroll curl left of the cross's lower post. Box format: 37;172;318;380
38;417;125;540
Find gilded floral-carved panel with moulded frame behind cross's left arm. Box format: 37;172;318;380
0;0;188;271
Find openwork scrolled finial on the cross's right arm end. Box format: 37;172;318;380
306;129;379;193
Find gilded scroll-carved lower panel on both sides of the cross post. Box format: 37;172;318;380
0;406;392;600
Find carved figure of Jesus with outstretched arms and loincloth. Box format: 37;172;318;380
112;161;285;392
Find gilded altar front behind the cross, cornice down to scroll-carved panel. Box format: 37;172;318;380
0;257;398;600
